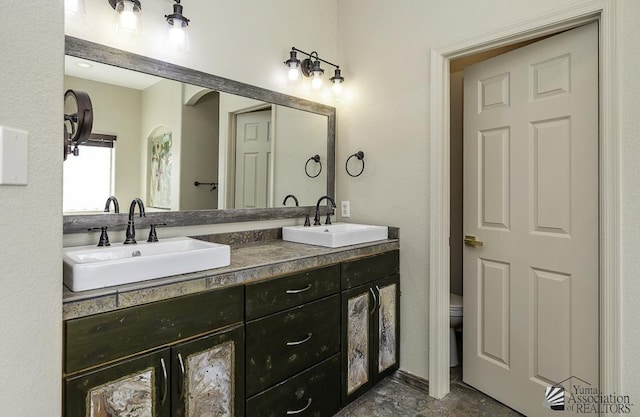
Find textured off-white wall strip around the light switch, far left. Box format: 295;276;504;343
0;0;64;417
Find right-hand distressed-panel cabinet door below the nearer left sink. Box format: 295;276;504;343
171;325;244;417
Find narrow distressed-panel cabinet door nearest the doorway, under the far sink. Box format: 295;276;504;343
373;274;400;382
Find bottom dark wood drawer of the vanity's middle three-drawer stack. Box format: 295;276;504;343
246;355;340;417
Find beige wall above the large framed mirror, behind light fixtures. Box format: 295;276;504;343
65;0;338;105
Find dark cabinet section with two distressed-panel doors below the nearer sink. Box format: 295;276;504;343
64;286;245;417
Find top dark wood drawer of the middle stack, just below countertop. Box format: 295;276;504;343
245;265;340;320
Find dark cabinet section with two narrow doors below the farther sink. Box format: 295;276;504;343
341;252;400;406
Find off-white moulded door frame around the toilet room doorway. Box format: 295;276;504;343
428;0;622;398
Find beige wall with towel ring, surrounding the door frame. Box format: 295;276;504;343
337;0;640;398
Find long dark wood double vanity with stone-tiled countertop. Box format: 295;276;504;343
63;223;400;417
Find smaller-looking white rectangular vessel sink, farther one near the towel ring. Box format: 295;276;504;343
282;223;389;248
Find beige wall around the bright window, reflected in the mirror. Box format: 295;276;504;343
64;76;145;206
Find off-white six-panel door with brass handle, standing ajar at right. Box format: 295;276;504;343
463;23;599;417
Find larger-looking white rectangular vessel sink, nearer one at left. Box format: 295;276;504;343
62;237;231;291
